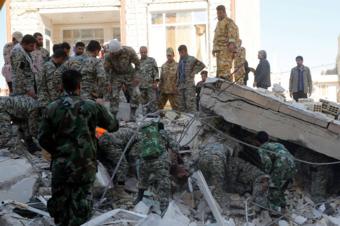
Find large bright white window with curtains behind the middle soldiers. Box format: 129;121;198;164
149;10;209;65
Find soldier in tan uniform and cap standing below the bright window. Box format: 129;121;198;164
159;48;178;110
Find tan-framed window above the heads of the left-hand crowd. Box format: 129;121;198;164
63;28;104;46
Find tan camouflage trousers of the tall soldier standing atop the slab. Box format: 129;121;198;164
216;50;233;82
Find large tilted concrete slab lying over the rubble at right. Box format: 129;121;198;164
201;86;340;159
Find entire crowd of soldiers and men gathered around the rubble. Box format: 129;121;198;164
0;3;312;225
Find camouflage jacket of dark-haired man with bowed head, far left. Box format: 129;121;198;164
11;45;36;95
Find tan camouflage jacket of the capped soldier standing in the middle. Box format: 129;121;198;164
159;61;178;94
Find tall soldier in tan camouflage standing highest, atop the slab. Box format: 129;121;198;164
212;5;240;81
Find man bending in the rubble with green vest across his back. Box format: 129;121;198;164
135;121;178;213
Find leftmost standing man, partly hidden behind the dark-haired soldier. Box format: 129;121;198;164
2;31;23;93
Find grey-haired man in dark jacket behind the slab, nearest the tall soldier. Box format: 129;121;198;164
253;50;271;89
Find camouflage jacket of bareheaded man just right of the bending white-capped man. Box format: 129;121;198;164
139;57;159;88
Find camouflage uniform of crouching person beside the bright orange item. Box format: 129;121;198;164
98;128;134;182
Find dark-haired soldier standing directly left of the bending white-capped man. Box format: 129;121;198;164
81;40;107;99
